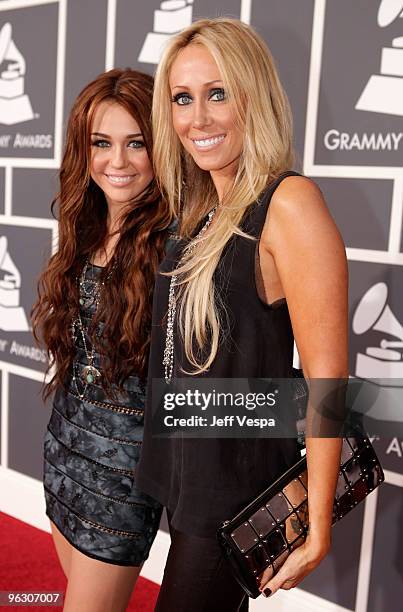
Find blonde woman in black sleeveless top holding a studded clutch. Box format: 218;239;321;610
138;18;348;612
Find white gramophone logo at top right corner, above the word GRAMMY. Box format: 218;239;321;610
355;0;403;116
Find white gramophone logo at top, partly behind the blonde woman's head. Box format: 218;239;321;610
138;0;193;64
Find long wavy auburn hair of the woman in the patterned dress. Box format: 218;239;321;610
32;69;172;398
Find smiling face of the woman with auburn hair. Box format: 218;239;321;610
91;102;154;212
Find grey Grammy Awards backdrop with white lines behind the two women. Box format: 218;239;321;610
0;0;403;612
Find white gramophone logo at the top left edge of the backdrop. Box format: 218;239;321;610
0;23;35;125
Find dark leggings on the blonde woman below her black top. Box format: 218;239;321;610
155;517;248;612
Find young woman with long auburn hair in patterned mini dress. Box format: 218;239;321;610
33;69;171;612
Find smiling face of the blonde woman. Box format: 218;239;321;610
169;44;243;191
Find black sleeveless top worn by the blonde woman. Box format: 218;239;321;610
136;172;300;537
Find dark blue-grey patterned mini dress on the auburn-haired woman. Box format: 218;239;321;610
44;264;162;566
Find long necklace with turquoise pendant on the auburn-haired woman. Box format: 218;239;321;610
72;258;115;399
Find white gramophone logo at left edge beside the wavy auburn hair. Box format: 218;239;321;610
0;236;29;331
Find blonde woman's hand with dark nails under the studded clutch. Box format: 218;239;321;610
259;540;330;597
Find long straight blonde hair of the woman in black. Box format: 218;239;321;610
152;17;293;374
